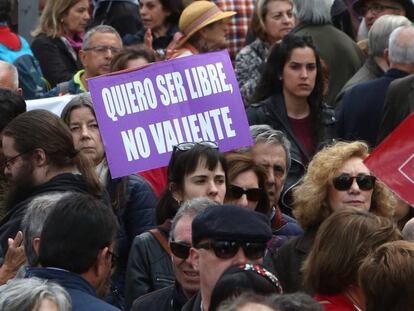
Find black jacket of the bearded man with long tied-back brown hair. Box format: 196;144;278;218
0;173;88;258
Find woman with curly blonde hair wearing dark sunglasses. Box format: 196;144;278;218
273;141;396;292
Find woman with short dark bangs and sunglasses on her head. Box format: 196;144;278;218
125;142;227;310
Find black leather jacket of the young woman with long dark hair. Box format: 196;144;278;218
247;94;335;214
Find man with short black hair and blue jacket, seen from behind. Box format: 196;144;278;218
26;194;119;311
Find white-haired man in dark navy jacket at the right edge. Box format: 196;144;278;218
337;26;414;147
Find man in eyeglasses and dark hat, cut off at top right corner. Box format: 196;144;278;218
353;0;414;30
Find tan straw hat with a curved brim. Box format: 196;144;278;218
177;0;236;47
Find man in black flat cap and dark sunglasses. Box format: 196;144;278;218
182;205;272;311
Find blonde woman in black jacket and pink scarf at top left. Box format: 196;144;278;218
31;0;90;87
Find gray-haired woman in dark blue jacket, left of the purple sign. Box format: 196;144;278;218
61;93;157;306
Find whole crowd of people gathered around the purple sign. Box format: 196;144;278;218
0;0;414;311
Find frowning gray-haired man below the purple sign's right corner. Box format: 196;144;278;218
249;124;304;241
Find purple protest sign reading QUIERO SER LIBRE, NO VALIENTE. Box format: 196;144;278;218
88;51;252;178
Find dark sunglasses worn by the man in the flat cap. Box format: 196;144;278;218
196;241;266;260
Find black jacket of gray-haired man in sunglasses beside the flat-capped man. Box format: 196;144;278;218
131;282;188;311
